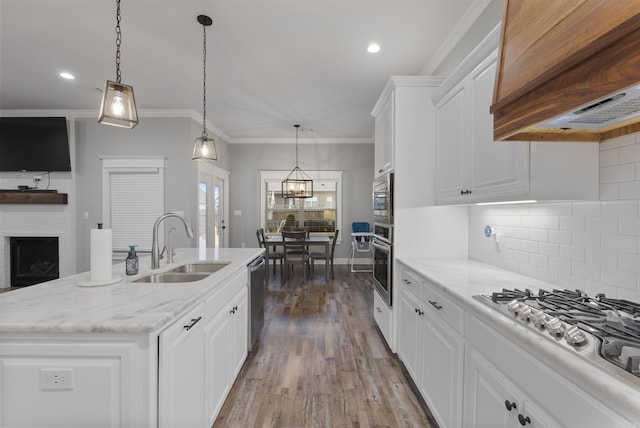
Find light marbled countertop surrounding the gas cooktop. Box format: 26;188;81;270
399;258;640;426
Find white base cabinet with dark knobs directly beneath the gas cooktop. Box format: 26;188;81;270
464;316;633;428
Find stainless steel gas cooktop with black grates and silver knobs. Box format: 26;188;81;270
474;289;640;387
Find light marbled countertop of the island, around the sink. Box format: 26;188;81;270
0;248;264;333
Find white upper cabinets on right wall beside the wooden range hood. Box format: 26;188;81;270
434;27;599;204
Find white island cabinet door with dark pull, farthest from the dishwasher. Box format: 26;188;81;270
158;304;204;428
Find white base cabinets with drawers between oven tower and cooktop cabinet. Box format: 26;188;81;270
398;265;464;427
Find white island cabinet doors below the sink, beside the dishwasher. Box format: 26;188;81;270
204;272;249;426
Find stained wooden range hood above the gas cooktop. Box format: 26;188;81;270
490;0;640;141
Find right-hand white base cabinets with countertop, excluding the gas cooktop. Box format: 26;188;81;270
396;258;640;428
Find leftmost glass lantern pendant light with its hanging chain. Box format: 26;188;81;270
98;0;138;129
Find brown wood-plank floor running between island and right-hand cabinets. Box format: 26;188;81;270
214;265;437;428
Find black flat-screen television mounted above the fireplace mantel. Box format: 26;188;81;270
0;117;71;172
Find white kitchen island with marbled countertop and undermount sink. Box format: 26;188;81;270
0;248;263;427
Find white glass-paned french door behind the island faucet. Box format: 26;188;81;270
198;162;229;248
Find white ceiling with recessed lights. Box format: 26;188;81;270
0;0;478;142
